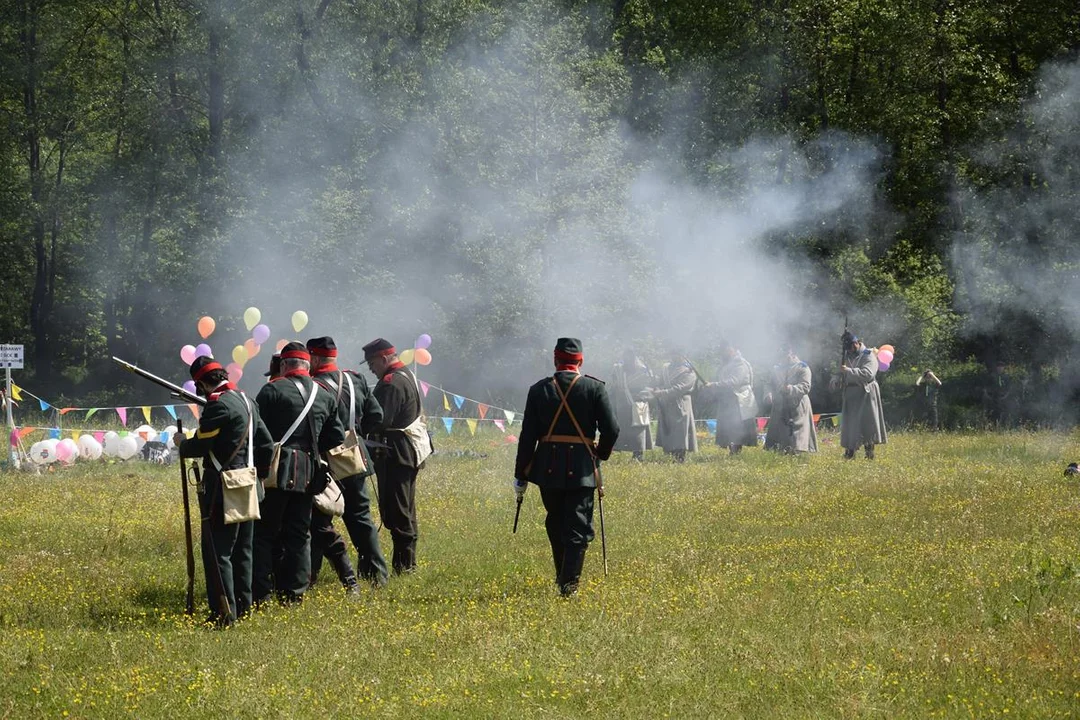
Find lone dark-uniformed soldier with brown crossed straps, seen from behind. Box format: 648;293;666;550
514;338;619;597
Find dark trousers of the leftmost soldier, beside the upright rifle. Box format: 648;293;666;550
199;473;255;620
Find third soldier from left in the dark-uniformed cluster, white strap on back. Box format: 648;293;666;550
308;337;388;587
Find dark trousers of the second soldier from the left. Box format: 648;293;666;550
252;488;311;602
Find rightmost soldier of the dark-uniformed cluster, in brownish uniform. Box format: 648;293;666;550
364;338;431;574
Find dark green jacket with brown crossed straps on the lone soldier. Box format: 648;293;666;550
514;371;619;489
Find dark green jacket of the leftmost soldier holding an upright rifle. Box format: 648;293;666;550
176;385;273;481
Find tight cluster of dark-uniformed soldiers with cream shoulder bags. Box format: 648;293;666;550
177;337;423;626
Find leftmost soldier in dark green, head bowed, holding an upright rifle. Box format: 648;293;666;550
174;356;273;626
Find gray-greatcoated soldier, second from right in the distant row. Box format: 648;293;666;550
765;343;818;452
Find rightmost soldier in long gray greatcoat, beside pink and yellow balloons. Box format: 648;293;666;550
840;331;888;460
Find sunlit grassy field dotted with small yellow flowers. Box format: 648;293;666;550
0;433;1080;718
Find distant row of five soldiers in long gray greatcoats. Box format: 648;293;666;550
612;332;888;462
